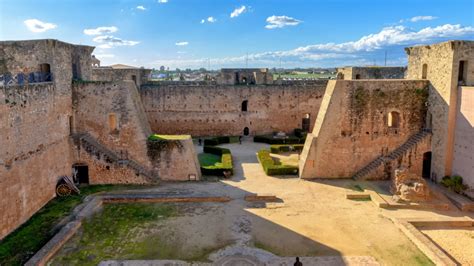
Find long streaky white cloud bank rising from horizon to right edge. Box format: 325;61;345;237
150;24;474;68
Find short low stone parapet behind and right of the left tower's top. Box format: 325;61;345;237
91;67;151;87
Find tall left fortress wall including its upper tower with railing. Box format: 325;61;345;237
0;40;93;239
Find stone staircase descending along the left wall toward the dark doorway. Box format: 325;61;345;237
72;133;158;179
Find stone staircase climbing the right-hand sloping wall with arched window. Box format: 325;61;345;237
352;129;431;180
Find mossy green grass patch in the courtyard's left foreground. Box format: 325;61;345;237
53;203;178;265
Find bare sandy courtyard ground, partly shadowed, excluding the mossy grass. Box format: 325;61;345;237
51;140;473;265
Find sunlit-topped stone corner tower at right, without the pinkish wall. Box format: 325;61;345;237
406;41;474;181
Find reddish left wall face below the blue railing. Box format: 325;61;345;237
0;82;72;239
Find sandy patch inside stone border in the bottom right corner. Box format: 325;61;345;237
419;227;474;265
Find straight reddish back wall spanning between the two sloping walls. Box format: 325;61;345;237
140;81;327;136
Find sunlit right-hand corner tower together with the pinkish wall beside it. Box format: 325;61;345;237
406;41;474;187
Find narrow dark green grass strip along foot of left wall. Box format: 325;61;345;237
0;185;143;265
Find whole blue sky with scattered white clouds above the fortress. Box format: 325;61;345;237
0;0;474;69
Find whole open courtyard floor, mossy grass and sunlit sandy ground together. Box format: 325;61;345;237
40;140;474;265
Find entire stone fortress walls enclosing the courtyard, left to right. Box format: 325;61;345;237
0;40;474;239
